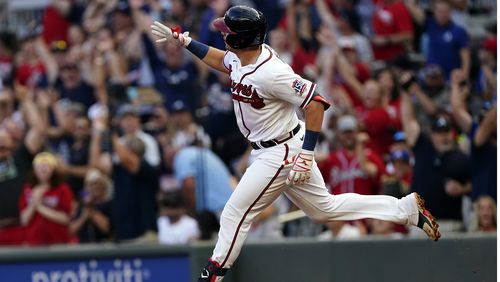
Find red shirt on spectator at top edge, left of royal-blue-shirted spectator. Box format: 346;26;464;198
373;0;413;60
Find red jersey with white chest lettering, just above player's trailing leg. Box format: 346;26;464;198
319;149;384;195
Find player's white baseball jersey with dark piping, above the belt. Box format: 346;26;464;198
224;44;316;142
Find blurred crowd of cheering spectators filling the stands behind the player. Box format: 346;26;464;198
0;0;497;245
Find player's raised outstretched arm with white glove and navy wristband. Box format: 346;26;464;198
151;22;229;73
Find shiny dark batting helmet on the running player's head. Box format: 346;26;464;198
213;6;267;49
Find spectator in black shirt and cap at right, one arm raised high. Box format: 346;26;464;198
401;74;472;232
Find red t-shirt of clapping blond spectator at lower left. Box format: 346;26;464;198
19;184;73;245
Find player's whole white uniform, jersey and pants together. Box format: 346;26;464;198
205;45;424;276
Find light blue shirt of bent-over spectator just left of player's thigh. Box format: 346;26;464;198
174;146;233;213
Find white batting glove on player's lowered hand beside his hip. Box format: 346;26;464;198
285;149;314;185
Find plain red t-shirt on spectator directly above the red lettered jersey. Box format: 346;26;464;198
360;108;398;156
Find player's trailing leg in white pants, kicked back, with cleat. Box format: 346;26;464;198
285;165;439;240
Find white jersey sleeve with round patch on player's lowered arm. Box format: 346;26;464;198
270;68;316;109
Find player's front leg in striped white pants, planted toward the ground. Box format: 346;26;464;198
199;146;286;281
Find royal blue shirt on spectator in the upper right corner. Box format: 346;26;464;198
425;18;469;79
